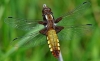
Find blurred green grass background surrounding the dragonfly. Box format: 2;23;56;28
0;0;100;61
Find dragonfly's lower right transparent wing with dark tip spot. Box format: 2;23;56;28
58;24;94;41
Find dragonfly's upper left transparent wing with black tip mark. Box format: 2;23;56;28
4;17;41;31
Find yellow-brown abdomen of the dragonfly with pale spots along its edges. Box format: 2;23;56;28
47;29;60;58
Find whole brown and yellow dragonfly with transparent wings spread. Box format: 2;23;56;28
5;2;92;58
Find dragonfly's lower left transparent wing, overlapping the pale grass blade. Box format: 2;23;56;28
11;33;46;48
